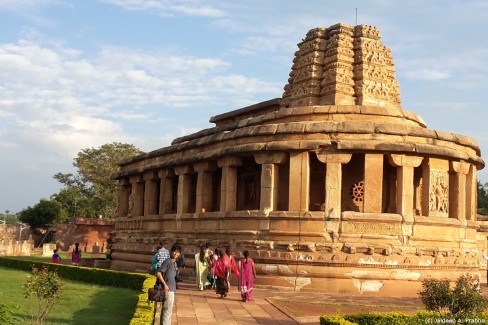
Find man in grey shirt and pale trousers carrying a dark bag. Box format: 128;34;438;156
156;245;181;325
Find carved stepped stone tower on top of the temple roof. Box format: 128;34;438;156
281;24;400;108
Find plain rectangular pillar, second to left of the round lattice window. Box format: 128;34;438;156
288;151;310;211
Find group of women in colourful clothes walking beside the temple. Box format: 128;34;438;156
195;243;256;301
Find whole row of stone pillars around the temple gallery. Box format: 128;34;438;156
118;152;476;221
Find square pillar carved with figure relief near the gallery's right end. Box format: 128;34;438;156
422;158;449;218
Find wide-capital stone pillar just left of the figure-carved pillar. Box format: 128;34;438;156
388;154;424;222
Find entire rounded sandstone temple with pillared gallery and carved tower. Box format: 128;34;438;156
112;24;486;295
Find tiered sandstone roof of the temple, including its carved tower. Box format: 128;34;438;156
114;24;485;172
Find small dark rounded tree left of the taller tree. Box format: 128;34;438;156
19;199;68;229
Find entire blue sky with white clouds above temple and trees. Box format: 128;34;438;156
0;0;488;212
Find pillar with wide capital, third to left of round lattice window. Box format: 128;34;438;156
254;152;288;215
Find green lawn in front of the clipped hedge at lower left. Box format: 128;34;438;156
0;267;139;325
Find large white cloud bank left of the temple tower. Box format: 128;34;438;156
0;33;282;171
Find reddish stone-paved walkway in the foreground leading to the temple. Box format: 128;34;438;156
158;281;422;325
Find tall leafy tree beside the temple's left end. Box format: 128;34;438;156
54;142;142;217
